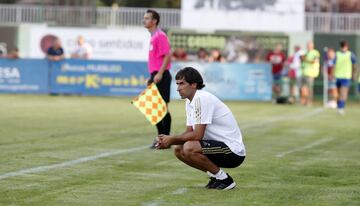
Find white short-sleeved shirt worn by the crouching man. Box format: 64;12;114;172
185;90;246;156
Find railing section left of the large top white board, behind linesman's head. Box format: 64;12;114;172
0;4;181;28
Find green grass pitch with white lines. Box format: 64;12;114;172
0;94;360;206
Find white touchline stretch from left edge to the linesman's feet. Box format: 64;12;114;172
0;145;149;180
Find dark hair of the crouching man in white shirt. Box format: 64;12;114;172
175;67;205;89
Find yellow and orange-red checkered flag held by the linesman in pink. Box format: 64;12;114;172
131;83;167;125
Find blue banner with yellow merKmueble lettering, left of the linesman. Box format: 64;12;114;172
50;59;149;96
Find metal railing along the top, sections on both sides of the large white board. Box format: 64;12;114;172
0;4;360;33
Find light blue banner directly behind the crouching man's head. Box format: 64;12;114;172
171;62;272;101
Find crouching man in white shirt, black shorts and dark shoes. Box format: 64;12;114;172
156;67;246;190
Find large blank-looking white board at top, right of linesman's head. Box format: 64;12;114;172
181;0;305;32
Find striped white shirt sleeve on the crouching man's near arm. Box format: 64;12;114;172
194;97;214;124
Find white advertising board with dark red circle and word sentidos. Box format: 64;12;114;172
27;26;150;61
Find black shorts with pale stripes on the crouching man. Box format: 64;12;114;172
200;140;245;168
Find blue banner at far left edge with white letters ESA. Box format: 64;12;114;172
0;59;49;94
